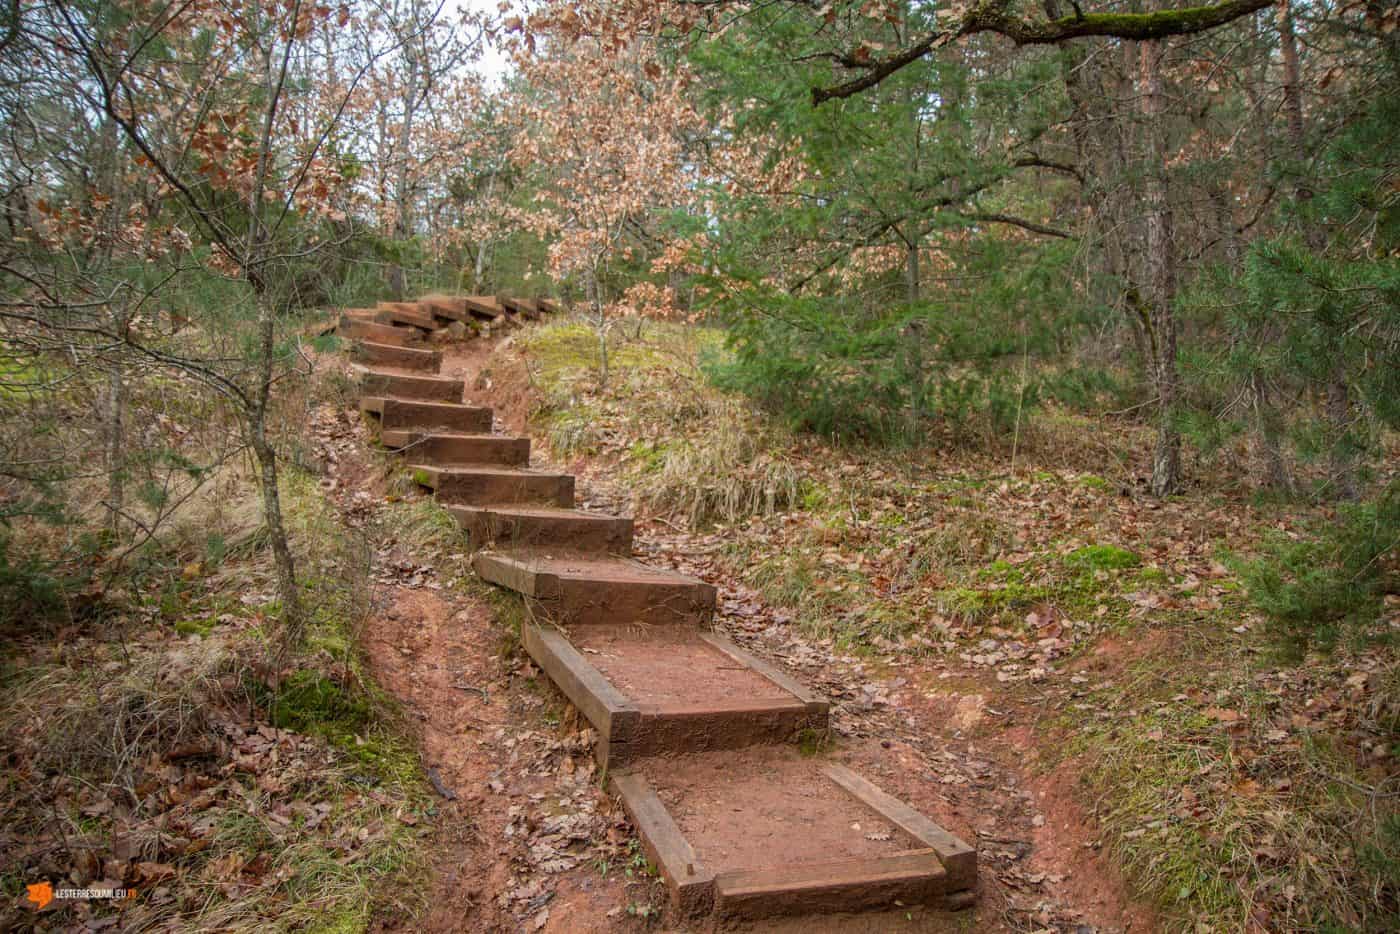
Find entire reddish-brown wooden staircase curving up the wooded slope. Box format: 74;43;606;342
339;295;977;917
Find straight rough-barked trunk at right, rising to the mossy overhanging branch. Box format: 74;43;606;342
1140;42;1182;496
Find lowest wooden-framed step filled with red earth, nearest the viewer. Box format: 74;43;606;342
612;749;977;919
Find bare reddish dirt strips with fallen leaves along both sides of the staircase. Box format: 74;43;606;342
318;340;1154;933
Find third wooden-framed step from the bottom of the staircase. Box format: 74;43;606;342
472;550;715;626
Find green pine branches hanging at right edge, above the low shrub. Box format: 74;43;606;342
1180;55;1400;494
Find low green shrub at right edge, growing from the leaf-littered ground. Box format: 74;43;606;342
1236;483;1400;654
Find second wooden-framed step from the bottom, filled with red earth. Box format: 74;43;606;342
521;623;827;769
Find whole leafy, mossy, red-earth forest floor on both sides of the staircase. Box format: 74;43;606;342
0;317;1400;933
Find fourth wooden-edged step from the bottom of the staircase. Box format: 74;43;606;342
448;503;631;555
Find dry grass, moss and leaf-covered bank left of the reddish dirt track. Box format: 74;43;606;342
0;469;431;931
